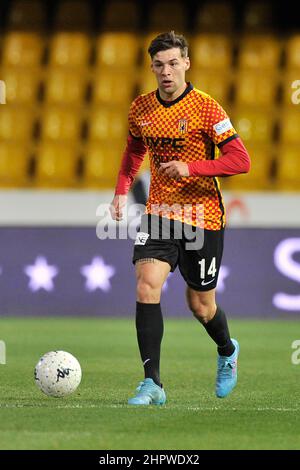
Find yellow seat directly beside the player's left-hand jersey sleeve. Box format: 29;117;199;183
89;106;128;142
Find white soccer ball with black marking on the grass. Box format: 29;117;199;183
34;351;81;397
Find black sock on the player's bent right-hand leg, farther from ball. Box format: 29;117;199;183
203;307;235;356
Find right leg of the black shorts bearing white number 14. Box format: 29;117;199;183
178;230;224;292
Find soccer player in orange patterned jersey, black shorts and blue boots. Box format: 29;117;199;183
110;31;250;405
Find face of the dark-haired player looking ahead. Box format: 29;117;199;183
151;47;190;100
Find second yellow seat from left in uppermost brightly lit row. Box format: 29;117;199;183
50;32;91;67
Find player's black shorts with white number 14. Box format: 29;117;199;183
132;214;224;291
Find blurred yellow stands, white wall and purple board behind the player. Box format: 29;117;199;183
0;0;300;316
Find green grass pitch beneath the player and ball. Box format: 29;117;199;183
0;318;300;450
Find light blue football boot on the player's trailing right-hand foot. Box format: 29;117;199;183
216;339;240;398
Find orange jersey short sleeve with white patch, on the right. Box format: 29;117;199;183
201;97;238;147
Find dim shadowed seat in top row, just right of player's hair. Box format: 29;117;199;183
194;1;234;34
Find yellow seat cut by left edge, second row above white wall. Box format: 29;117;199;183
0;104;35;142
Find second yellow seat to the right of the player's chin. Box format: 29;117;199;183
235;69;278;106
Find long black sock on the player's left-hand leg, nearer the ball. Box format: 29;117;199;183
136;302;164;386
